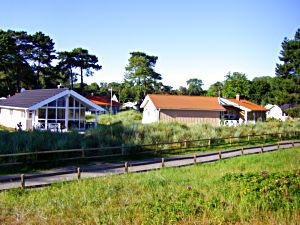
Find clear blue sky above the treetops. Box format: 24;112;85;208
0;0;300;88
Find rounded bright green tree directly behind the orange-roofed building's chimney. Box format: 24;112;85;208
223;72;250;98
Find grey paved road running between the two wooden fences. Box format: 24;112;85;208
0;142;300;190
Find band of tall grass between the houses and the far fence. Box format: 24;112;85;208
0;111;300;153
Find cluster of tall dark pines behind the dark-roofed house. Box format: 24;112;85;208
0;30;101;96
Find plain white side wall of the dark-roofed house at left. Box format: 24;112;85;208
0;108;26;130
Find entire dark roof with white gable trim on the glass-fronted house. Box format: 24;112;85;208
0;88;106;112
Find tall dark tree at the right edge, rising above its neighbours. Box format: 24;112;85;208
276;28;300;77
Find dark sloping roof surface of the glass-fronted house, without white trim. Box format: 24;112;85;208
0;88;67;108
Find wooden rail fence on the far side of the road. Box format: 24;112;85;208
0;131;300;166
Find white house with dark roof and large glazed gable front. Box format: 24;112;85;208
0;88;106;131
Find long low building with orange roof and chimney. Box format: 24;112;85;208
141;94;267;125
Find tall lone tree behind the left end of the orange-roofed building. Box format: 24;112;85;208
125;52;162;101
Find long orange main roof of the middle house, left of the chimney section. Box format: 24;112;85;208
141;94;225;111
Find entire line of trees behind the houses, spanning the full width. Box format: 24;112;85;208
0;29;300;110
